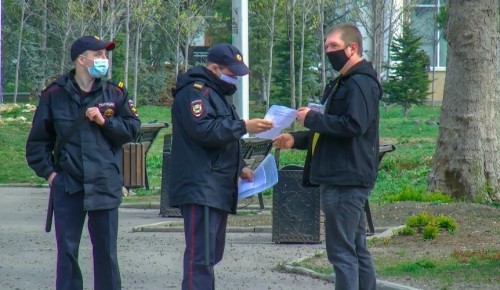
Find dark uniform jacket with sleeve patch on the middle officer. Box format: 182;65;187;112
169;67;246;213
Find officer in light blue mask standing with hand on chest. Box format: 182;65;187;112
26;36;140;290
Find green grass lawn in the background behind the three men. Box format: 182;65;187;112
0;104;440;204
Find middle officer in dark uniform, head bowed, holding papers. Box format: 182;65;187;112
169;44;272;290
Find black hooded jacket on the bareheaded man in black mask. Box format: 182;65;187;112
292;60;382;188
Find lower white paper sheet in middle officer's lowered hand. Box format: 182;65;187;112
238;154;278;200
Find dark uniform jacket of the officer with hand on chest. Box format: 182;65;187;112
26;70;140;210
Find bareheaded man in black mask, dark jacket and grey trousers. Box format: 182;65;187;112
275;24;382;290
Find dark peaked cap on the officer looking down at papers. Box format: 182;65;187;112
207;44;250;76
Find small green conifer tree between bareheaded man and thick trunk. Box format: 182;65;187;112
382;23;430;117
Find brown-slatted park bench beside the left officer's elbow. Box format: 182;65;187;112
122;121;169;190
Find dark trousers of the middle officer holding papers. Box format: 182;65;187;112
181;205;228;290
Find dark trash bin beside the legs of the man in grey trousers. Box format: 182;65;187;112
272;165;324;243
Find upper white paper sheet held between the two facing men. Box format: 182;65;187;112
255;105;297;140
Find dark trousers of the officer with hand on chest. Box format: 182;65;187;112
51;173;121;290
